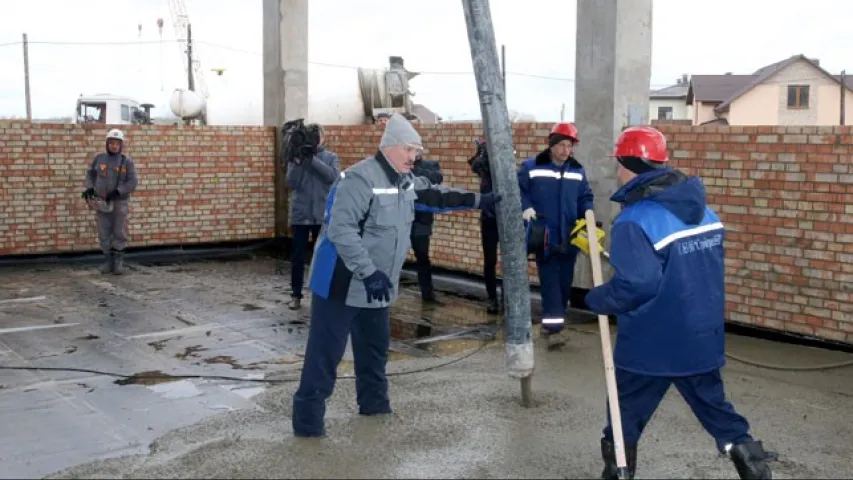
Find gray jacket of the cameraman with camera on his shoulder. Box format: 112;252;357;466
287;147;341;225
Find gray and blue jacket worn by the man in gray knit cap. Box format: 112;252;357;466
310;152;480;308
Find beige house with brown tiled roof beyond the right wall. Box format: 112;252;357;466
684;55;853;125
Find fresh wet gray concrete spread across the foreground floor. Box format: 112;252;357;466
45;329;853;478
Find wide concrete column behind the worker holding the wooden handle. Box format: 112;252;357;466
574;0;652;288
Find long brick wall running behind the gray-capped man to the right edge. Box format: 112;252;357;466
327;124;853;343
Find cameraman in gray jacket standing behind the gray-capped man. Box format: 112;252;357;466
287;125;340;310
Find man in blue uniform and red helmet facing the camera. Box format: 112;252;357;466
518;123;593;348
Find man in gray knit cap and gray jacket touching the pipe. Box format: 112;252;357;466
292;114;500;437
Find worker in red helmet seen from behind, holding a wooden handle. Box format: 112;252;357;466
586;126;771;479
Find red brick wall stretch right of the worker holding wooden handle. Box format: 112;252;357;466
662;126;853;343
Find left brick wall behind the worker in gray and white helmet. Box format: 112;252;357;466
0;122;274;255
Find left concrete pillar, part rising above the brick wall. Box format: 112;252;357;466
263;0;308;126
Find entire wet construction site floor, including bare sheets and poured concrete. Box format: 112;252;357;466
0;258;853;478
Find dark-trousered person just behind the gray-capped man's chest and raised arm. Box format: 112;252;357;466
411;154;444;304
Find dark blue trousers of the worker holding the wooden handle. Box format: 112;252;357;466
603;368;752;452
